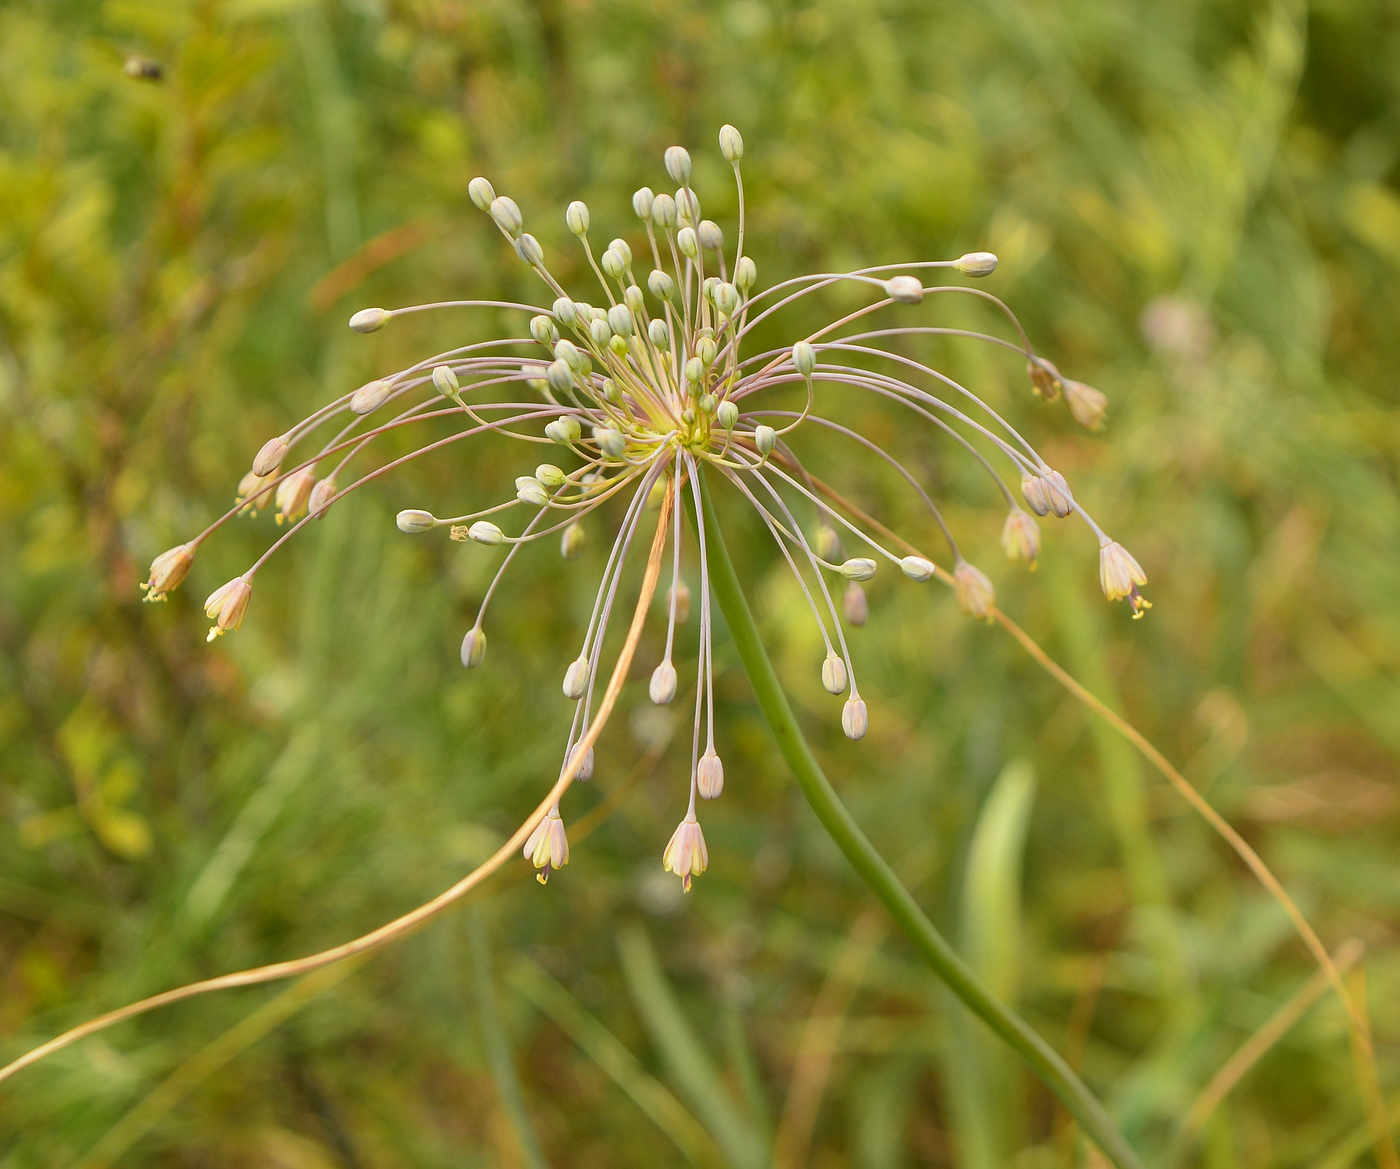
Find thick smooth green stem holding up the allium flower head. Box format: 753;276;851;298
700;470;1142;1169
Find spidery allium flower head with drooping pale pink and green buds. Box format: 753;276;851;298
147;126;1147;889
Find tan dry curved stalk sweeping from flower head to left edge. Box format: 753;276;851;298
0;477;675;1081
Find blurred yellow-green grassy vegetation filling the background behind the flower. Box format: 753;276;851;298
0;0;1400;1169
